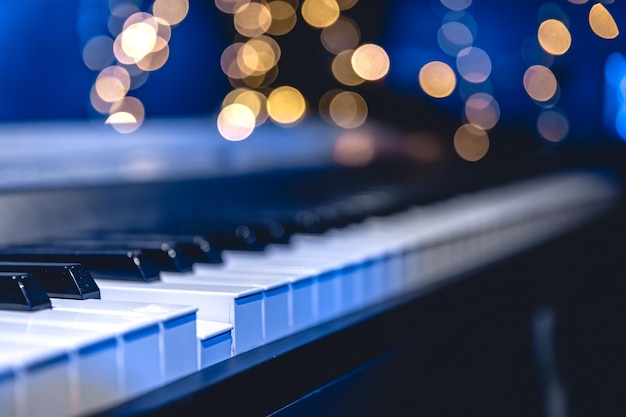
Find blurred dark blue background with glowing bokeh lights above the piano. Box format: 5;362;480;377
0;0;626;162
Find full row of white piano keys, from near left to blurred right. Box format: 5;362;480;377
0;167;618;417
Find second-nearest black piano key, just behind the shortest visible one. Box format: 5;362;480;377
0;262;100;300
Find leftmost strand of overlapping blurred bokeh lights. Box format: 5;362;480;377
82;0;189;133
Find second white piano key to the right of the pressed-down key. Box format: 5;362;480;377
160;272;293;343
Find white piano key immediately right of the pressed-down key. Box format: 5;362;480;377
96;279;263;354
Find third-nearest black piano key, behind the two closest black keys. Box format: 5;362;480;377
0;246;160;281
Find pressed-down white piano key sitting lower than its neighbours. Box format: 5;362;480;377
196;320;233;369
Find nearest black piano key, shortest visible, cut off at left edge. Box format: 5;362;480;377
0;272;52;311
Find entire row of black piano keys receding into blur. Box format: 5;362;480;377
0;177;428;311
